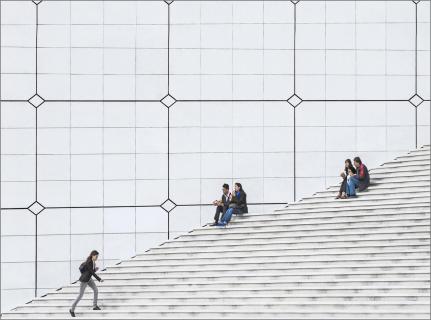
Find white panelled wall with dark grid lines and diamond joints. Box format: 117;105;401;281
1;1;430;310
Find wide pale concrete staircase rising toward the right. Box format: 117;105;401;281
3;146;430;320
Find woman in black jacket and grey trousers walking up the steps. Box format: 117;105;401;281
69;250;103;317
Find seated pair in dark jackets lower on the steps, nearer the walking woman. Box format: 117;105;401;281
211;182;248;227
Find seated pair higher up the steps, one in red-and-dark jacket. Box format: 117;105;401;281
336;157;370;199
